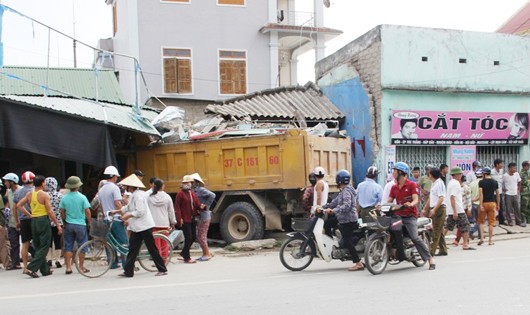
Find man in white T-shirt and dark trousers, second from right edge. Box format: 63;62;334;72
502;163;522;226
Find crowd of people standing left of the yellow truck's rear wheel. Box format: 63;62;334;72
0;166;215;278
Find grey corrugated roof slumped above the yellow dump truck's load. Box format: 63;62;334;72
205;82;344;120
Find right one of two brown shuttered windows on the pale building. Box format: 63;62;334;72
219;50;247;94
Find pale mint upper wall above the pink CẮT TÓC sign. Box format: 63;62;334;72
381;25;530;93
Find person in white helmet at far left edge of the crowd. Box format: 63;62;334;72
2;173;21;270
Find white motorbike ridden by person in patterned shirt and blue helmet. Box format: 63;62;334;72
280;210;369;271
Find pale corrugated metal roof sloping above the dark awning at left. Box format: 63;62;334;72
0;95;160;136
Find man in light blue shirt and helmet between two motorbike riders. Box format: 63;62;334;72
357;166;383;222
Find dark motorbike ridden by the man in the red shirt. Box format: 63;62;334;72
364;204;432;275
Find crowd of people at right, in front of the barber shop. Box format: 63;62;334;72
302;159;530;271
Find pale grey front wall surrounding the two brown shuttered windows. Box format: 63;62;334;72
115;0;271;101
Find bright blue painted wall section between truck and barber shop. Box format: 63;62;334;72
319;73;374;185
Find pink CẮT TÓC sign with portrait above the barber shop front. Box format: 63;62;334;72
392;110;529;145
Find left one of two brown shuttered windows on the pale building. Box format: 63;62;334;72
163;48;192;94
